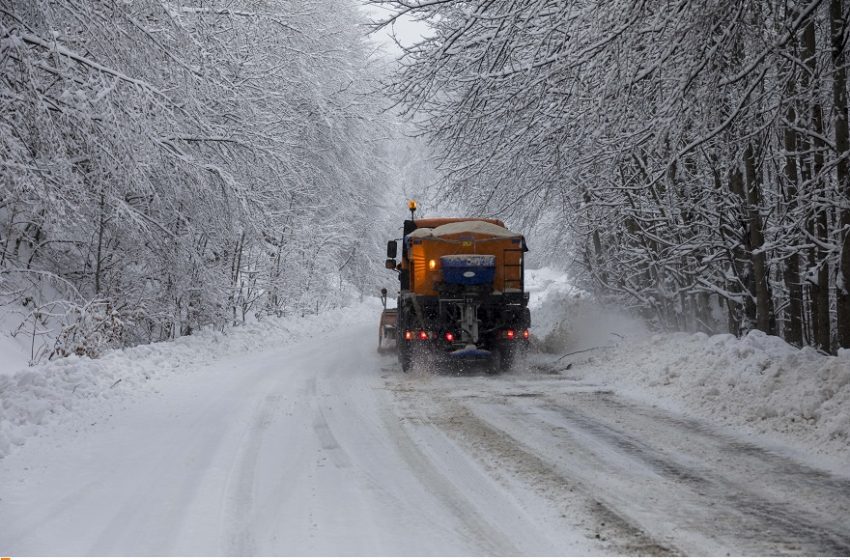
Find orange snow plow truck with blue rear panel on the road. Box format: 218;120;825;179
379;201;531;374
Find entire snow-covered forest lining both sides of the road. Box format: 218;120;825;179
0;0;850;361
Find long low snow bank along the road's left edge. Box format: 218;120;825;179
0;298;381;457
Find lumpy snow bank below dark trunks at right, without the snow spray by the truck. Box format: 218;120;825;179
561;331;850;461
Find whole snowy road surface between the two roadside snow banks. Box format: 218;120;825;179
0;321;850;556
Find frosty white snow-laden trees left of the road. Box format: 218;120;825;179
0;0;404;361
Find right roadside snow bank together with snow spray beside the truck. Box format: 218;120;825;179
527;269;850;472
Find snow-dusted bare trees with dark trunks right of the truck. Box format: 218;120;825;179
371;0;850;352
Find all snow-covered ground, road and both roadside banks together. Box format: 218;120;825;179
0;270;850;555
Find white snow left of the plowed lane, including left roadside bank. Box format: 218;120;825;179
0;301;605;556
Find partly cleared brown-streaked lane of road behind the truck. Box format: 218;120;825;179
458;392;850;555
